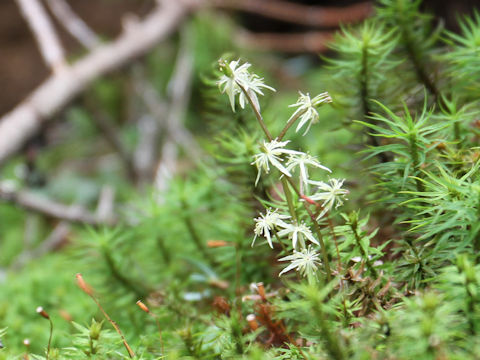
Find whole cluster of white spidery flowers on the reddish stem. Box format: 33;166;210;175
217;60;348;276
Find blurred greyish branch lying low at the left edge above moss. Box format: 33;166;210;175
0;183;115;226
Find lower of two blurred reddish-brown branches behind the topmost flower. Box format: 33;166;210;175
238;31;333;53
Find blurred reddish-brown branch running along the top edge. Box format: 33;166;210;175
209;0;373;27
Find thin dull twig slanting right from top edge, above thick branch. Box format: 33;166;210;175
47;0;100;50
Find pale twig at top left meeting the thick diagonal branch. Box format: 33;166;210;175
16;0;66;71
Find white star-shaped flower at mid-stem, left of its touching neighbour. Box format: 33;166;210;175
251;139;301;186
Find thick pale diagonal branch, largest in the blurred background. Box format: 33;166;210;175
0;0;190;163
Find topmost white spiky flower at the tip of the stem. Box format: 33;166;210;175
217;60;275;112
